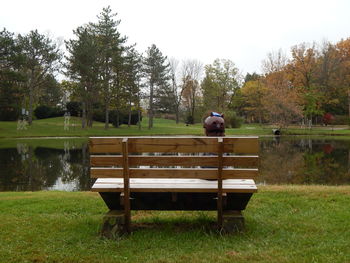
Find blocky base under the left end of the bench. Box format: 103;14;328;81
100;210;125;239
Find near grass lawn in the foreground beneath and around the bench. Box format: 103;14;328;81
0;186;350;263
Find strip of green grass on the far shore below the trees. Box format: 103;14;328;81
0;117;350;138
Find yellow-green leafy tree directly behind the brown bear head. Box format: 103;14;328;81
202;59;240;112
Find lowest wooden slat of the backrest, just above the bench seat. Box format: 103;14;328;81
90;168;258;179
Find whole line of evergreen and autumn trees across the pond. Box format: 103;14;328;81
0;7;350;129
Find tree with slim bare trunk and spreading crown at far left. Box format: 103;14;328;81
18;30;62;125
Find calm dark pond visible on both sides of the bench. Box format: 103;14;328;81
0;136;350;191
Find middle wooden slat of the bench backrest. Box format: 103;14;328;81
90;155;259;167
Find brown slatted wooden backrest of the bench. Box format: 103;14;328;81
89;137;258;182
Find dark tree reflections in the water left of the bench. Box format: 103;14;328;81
0;143;91;191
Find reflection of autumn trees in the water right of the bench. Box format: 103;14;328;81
259;139;350;185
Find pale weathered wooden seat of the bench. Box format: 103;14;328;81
91;178;257;193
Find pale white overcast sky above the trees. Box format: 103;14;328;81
0;0;350;73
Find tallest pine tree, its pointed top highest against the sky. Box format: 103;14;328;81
91;6;126;129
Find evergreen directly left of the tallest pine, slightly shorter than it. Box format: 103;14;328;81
66;26;99;128
